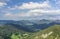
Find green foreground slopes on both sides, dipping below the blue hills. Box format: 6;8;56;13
0;25;60;39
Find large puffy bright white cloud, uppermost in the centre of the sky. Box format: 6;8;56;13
19;1;51;9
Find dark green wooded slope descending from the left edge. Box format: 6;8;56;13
0;24;32;39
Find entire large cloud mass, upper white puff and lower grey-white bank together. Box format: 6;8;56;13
0;1;60;19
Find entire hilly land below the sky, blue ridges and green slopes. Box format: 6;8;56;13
0;20;60;39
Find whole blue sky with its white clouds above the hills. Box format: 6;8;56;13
0;0;60;20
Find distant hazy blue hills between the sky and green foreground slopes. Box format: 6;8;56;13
0;19;60;32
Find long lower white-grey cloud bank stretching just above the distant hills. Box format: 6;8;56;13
5;10;60;20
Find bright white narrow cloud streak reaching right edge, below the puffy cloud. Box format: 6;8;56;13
29;9;60;14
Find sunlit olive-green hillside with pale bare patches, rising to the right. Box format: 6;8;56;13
29;25;60;39
